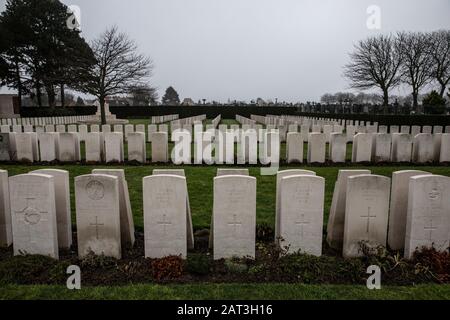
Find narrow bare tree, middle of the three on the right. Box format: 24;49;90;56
398;32;432;111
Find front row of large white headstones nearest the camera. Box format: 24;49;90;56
0;169;450;259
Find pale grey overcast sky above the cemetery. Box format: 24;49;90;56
0;0;450;102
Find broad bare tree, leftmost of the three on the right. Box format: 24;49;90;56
344;35;401;112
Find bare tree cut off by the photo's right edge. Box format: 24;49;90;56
428;30;450;98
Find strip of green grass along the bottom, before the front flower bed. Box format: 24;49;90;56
0;284;450;300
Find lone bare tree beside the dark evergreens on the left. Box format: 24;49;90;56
83;26;153;124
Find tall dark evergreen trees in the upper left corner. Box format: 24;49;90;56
0;0;95;106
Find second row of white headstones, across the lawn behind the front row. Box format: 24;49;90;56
0;128;450;164
